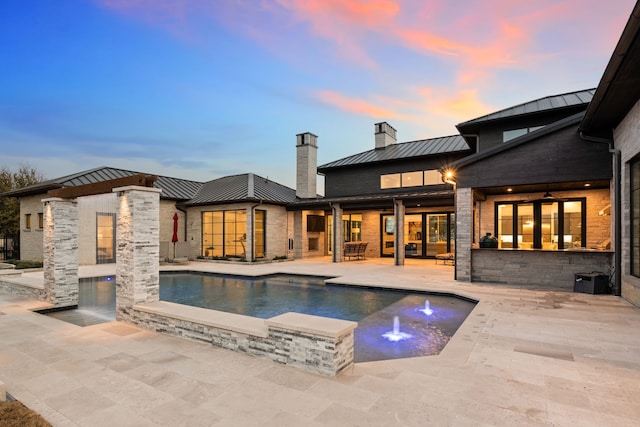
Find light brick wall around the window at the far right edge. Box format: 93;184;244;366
614;101;640;307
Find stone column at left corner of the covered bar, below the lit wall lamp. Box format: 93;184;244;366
455;188;473;282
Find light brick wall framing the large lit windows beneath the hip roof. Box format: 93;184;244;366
182;203;289;259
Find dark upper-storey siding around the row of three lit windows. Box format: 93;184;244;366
325;155;463;198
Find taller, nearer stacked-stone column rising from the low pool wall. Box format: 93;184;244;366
113;186;162;321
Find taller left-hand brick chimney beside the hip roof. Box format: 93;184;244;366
296;132;318;199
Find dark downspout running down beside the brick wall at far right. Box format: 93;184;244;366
579;131;622;296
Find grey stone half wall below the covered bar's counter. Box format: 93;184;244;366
471;249;613;292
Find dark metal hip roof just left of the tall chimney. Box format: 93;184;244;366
186;173;296;206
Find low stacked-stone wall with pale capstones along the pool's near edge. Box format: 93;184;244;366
130;304;357;376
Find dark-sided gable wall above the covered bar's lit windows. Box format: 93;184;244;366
456;126;612;188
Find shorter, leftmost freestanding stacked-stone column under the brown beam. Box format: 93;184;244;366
42;198;78;306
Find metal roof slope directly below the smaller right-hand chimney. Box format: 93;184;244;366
318;135;469;170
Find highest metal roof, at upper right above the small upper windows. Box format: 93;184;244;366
456;89;596;129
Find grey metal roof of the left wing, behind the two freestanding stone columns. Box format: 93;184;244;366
2;166;202;200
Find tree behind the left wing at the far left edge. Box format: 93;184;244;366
0;165;44;236
